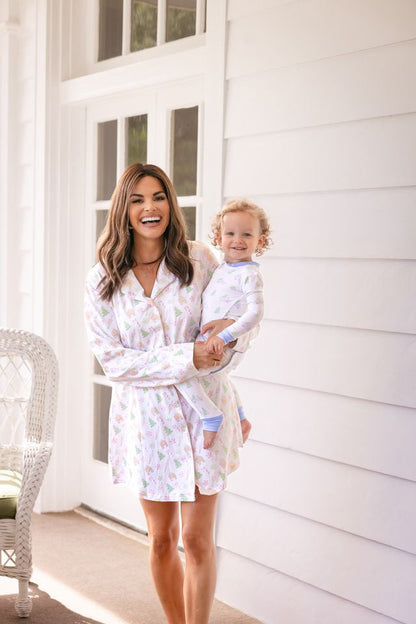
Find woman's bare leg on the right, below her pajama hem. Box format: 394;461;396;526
181;489;218;624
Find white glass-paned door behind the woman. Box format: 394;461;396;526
82;85;202;530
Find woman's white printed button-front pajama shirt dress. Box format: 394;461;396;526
85;243;242;501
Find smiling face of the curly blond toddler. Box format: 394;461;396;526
218;211;264;262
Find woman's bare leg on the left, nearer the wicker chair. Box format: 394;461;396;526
140;499;186;624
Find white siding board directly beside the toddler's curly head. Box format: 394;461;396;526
250;187;416;260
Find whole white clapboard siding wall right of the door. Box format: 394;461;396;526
217;0;416;624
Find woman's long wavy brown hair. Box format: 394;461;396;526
97;163;194;301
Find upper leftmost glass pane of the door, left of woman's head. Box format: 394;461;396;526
97;119;117;200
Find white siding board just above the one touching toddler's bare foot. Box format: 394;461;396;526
238;321;416;407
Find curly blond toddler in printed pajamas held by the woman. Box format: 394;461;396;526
176;199;271;448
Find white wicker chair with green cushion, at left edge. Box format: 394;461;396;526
0;329;58;617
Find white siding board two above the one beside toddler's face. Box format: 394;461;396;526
225;40;416;137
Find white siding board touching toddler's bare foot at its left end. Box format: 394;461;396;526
233;371;416;482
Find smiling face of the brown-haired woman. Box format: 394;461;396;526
129;176;170;241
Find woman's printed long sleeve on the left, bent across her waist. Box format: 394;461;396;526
85;270;197;388
